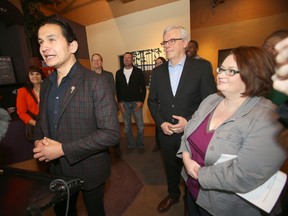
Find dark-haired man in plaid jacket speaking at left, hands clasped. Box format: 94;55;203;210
33;19;120;216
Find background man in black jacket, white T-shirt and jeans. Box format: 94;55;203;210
116;52;146;154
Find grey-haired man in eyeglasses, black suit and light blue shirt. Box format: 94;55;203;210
148;26;216;213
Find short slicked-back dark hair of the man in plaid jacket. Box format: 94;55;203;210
39;18;77;43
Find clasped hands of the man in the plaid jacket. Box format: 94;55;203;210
33;137;64;162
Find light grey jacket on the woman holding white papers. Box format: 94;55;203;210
177;94;285;216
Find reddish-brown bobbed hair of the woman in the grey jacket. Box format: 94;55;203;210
231;46;275;97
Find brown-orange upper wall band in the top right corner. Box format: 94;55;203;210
190;0;288;29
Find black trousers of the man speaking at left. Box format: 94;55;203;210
54;184;105;216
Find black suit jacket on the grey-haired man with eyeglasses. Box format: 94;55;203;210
148;58;216;128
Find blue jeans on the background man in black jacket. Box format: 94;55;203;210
122;101;144;148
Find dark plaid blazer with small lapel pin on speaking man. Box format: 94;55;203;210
36;62;120;190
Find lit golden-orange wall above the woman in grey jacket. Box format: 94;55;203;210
191;12;288;76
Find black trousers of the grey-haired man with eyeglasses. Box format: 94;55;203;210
158;132;183;200
